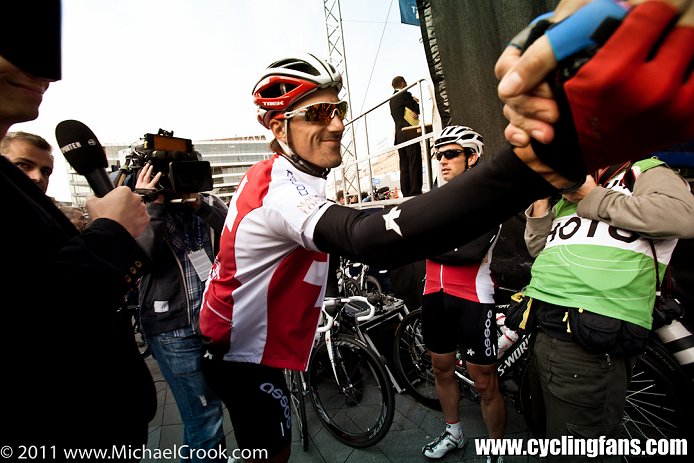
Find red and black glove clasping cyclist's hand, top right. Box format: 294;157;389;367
564;2;694;172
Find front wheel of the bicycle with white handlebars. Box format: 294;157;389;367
308;336;395;448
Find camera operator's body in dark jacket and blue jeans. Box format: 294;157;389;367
135;162;227;461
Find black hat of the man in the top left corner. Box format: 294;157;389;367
0;0;61;80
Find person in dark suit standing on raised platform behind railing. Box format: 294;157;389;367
390;76;422;196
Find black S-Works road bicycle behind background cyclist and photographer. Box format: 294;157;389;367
393;294;694;456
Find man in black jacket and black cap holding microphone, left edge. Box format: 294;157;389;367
0;0;157;461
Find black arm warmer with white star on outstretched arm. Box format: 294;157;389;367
314;145;557;269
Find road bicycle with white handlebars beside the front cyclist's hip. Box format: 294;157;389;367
286;294;414;450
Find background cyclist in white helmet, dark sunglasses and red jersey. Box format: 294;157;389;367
422;125;506;458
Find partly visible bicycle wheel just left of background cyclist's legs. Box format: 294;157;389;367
393;309;441;410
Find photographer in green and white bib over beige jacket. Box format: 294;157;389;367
523;159;694;461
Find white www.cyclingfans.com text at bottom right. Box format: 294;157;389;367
475;436;687;458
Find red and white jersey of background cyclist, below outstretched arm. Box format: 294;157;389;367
424;235;498;304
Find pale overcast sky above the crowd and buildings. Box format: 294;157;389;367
11;0;429;200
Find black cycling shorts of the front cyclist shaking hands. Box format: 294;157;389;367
203;355;292;457
